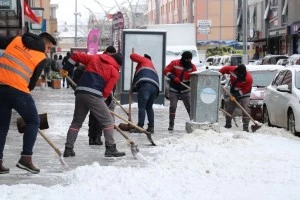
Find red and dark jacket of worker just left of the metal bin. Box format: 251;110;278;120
164;59;197;93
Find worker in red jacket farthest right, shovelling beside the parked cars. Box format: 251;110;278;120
219;64;253;132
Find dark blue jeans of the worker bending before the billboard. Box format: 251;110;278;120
138;82;158;127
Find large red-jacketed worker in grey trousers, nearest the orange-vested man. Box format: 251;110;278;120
61;52;125;157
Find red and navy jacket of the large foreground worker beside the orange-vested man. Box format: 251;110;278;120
68;52;119;98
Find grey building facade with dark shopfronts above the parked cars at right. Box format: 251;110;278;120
236;0;300;58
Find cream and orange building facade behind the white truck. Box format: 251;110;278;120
148;0;237;44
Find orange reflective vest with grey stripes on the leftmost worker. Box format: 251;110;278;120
0;36;46;93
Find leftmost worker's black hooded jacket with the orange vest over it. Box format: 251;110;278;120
0;33;50;93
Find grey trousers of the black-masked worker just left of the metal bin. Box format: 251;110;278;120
169;90;191;126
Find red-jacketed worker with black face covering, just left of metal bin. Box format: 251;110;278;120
164;51;197;131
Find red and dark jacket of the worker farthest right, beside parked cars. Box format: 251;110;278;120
219;66;253;97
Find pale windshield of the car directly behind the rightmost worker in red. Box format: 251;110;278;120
250;70;278;87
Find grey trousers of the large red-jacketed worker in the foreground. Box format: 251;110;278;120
65;93;115;148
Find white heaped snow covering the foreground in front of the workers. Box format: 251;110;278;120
0;128;300;200
